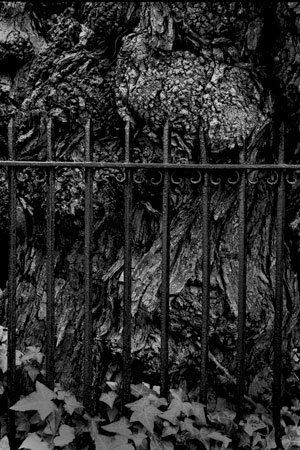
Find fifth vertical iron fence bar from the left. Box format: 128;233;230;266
160;120;170;397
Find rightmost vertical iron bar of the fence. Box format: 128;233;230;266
273;123;285;442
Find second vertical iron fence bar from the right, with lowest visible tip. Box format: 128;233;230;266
237;147;247;417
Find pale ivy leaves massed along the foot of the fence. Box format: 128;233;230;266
0;326;300;450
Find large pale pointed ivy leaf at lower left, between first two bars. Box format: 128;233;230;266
10;381;56;420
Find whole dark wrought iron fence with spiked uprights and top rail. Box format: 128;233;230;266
0;119;300;442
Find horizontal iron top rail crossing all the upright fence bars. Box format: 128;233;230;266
0;160;300;171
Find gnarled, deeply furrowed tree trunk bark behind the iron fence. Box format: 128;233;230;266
0;1;300;404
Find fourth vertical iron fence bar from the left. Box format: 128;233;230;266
123;120;132;404
